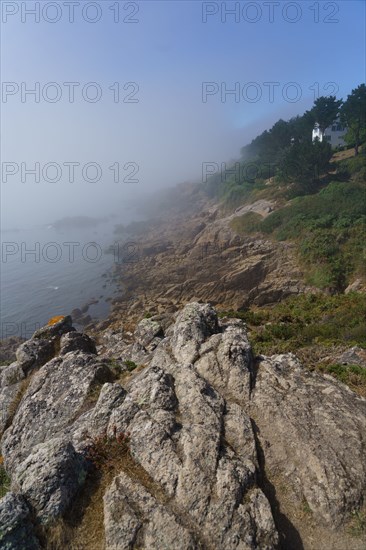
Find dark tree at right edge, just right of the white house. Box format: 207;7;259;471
341;84;366;156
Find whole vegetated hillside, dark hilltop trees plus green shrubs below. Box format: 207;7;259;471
206;84;366;292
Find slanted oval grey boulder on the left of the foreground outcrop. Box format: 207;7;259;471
2;352;114;472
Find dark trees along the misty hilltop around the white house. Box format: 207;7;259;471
205;84;366;210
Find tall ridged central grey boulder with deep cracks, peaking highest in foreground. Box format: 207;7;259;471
104;303;278;550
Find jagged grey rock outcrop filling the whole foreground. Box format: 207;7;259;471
0;308;366;550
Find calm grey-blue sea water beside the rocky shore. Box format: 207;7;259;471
0;221;129;338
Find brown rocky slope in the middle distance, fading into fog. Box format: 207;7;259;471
104;205;307;330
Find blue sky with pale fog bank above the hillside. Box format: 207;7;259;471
1;0;366;228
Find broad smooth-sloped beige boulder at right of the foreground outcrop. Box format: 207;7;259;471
250;354;366;527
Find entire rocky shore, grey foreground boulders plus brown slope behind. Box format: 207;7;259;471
0;192;366;550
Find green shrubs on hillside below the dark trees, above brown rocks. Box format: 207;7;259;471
231;180;366;292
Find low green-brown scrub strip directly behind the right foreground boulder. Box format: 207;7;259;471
219;292;366;396
